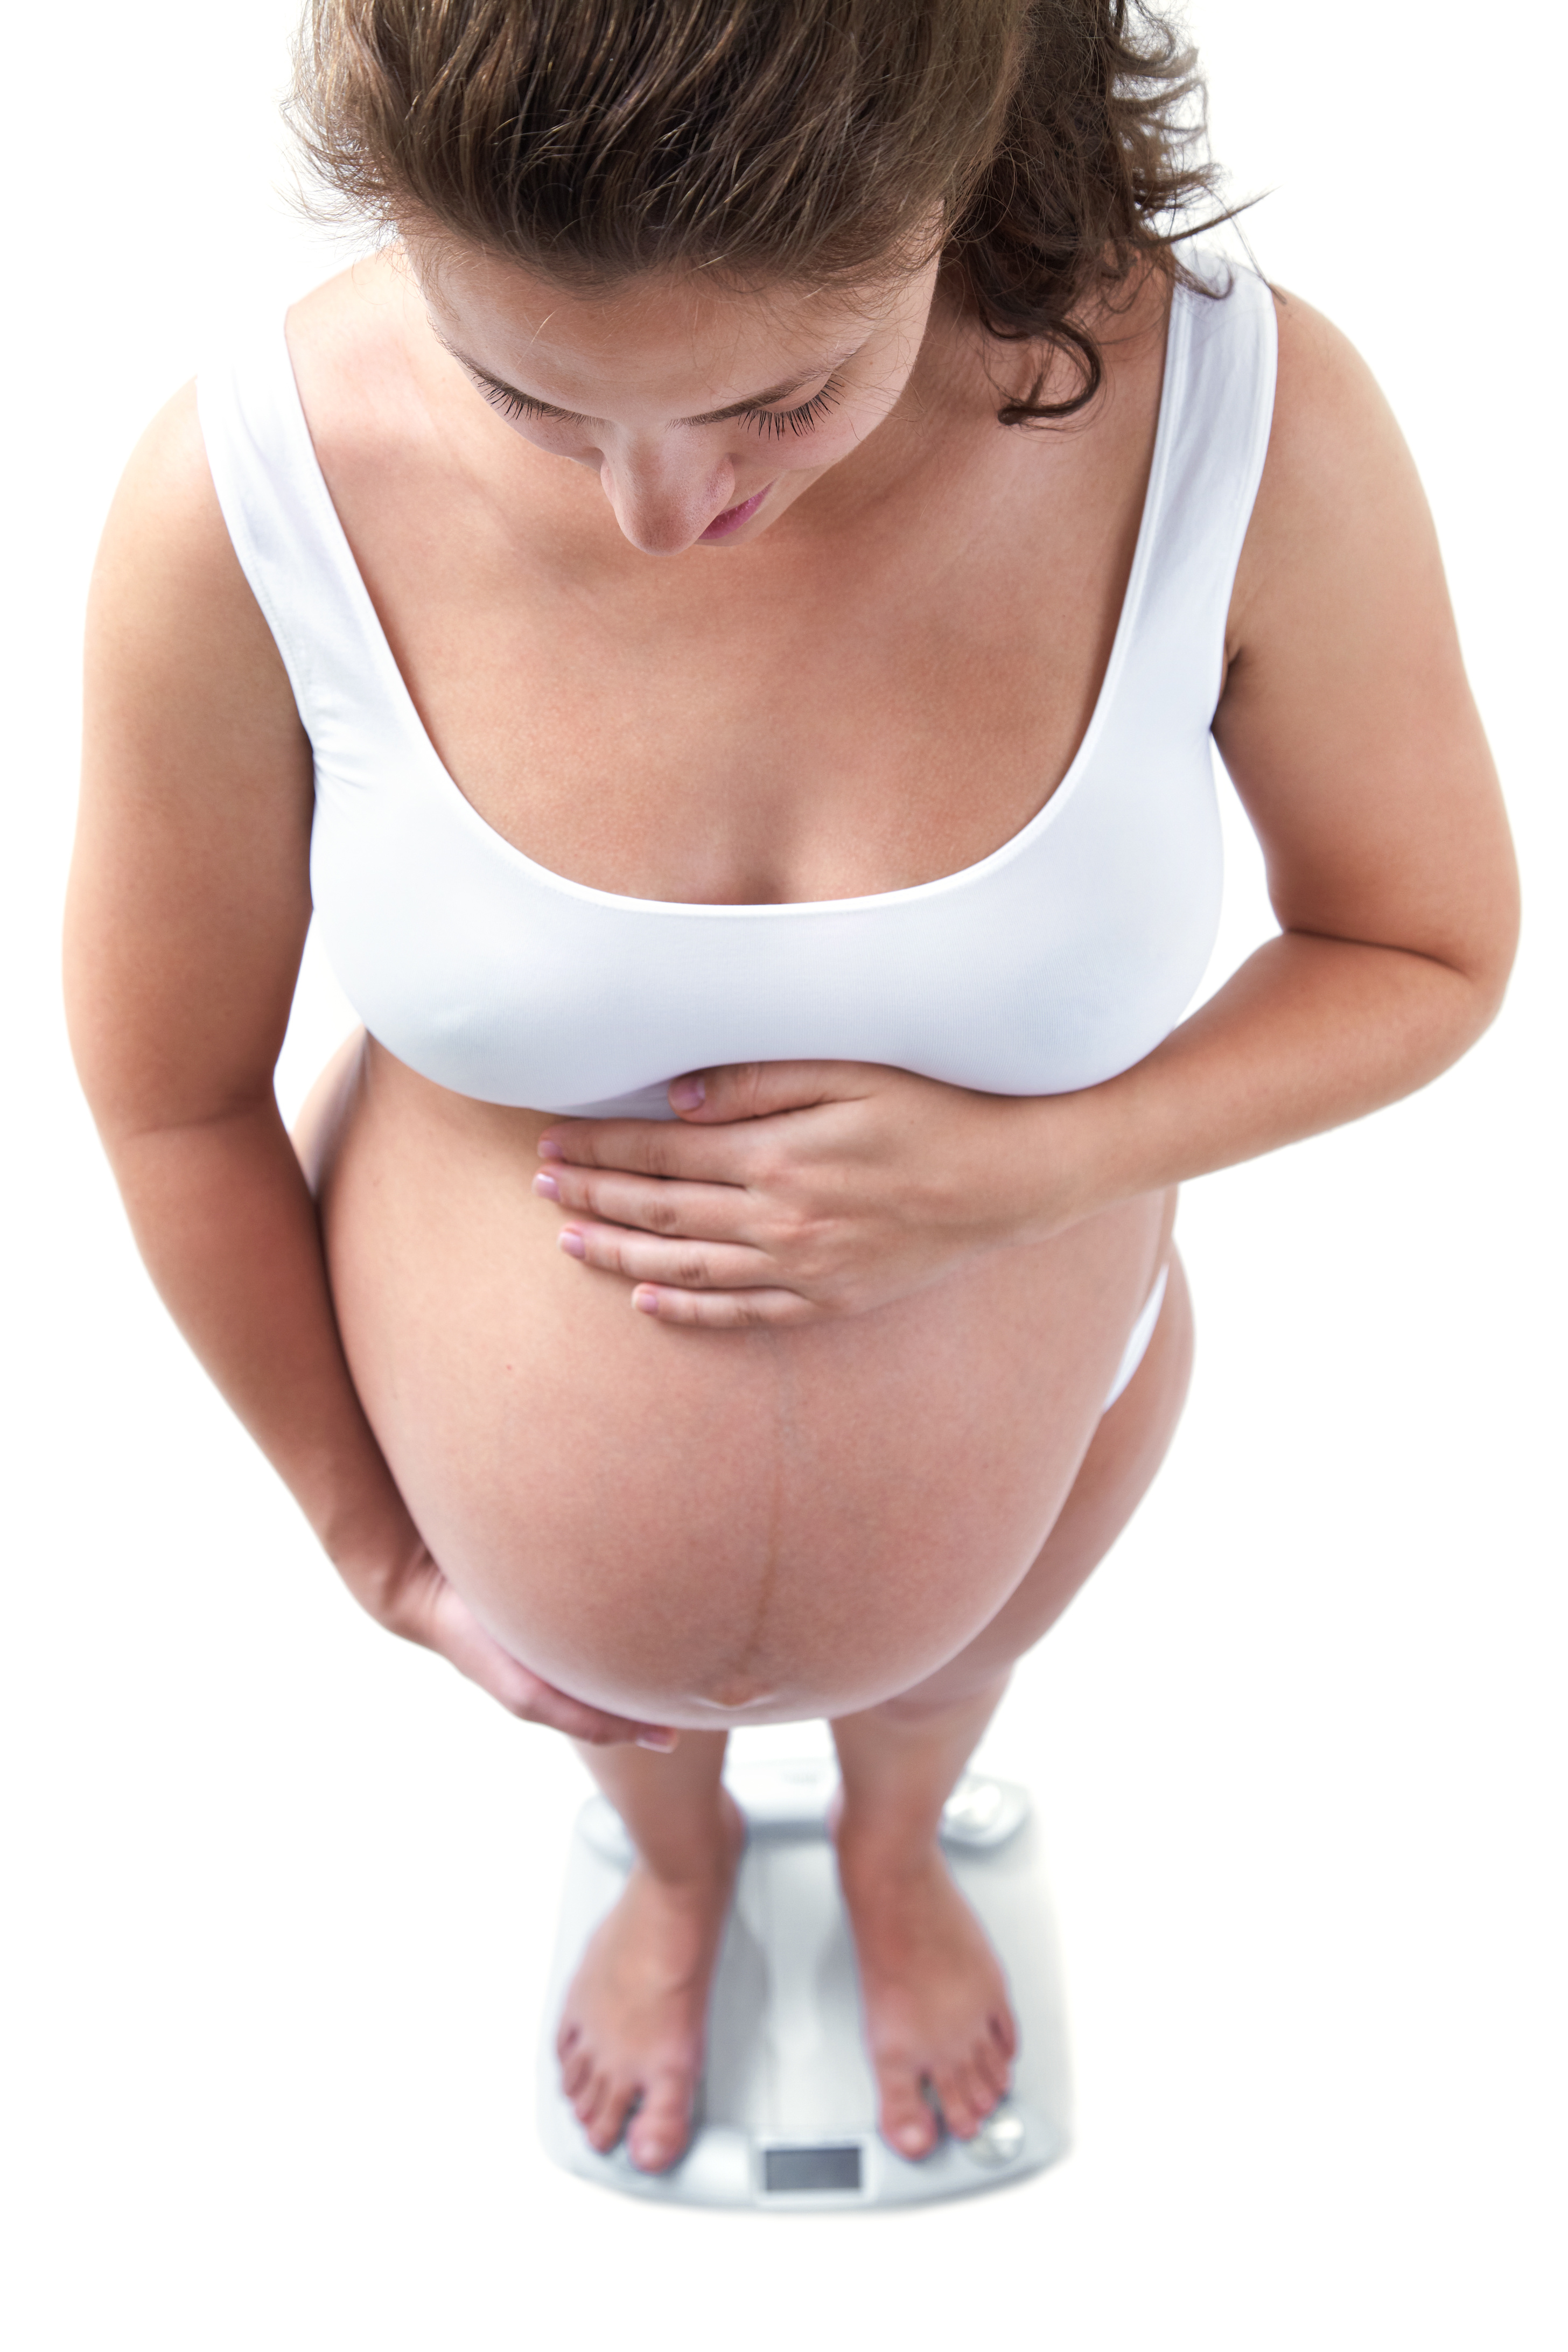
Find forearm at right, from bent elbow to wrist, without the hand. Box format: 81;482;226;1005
1041;932;1507;1223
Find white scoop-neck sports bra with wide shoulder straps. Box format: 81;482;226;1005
198;261;1274;1119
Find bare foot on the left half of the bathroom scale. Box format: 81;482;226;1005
555;1790;745;2173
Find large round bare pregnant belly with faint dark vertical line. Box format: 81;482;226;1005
320;1049;1164;1728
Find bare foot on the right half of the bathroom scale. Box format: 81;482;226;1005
837;1830;1018;2157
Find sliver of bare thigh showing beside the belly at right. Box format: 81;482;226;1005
884;1249;1192;1714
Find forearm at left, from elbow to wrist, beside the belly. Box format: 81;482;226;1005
106;1101;421;1623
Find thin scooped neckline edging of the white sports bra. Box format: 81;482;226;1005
277;282;1192;920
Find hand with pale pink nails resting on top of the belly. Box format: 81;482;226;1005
534;1061;1055;1329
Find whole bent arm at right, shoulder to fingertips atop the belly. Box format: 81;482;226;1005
524;301;1518;1327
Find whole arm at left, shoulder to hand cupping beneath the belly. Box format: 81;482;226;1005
66;393;673;1745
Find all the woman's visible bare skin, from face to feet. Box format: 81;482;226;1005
68;235;1516;2168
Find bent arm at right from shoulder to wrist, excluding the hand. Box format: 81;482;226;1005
1030;279;1518;1202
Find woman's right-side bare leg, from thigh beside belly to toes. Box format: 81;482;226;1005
832;1256;1192;2157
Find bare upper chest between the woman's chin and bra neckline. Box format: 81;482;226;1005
334;386;1157;903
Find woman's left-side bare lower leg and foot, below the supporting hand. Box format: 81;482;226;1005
555;1731;745;2173
